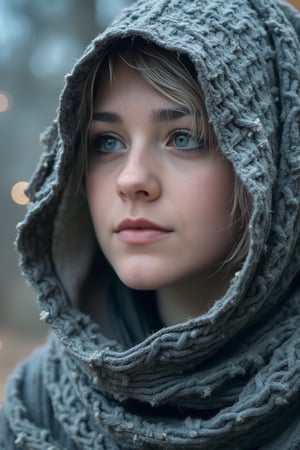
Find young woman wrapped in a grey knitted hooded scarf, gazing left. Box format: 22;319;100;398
0;0;300;450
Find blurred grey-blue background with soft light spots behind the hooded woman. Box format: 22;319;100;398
0;0;300;400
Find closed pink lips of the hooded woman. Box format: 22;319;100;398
115;218;172;245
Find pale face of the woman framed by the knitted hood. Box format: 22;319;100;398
86;59;234;289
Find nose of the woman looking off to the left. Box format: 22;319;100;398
117;148;161;201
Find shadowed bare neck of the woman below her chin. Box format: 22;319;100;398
157;271;232;326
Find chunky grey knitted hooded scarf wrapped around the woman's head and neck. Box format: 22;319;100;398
0;0;300;450
